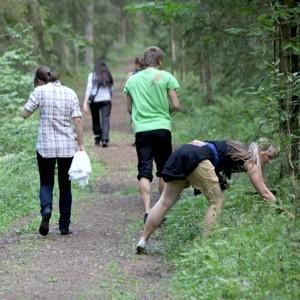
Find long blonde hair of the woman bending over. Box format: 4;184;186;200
227;138;278;168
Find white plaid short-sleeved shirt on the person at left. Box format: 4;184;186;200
24;81;82;158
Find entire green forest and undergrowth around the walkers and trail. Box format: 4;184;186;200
0;0;300;299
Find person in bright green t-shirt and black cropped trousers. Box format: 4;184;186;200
124;47;180;221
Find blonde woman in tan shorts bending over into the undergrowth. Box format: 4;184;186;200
137;139;278;254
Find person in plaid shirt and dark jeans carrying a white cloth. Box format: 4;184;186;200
22;66;84;236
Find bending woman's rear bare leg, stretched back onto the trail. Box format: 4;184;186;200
137;181;186;253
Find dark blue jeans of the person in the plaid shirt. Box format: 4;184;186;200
37;152;73;229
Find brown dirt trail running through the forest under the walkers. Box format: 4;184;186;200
0;59;171;300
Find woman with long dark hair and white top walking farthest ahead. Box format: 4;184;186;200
83;60;114;147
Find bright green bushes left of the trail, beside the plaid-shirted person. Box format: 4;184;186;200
0;24;42;232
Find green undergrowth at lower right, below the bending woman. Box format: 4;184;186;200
164;185;300;299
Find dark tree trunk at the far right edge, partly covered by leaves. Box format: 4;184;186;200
278;0;300;217
